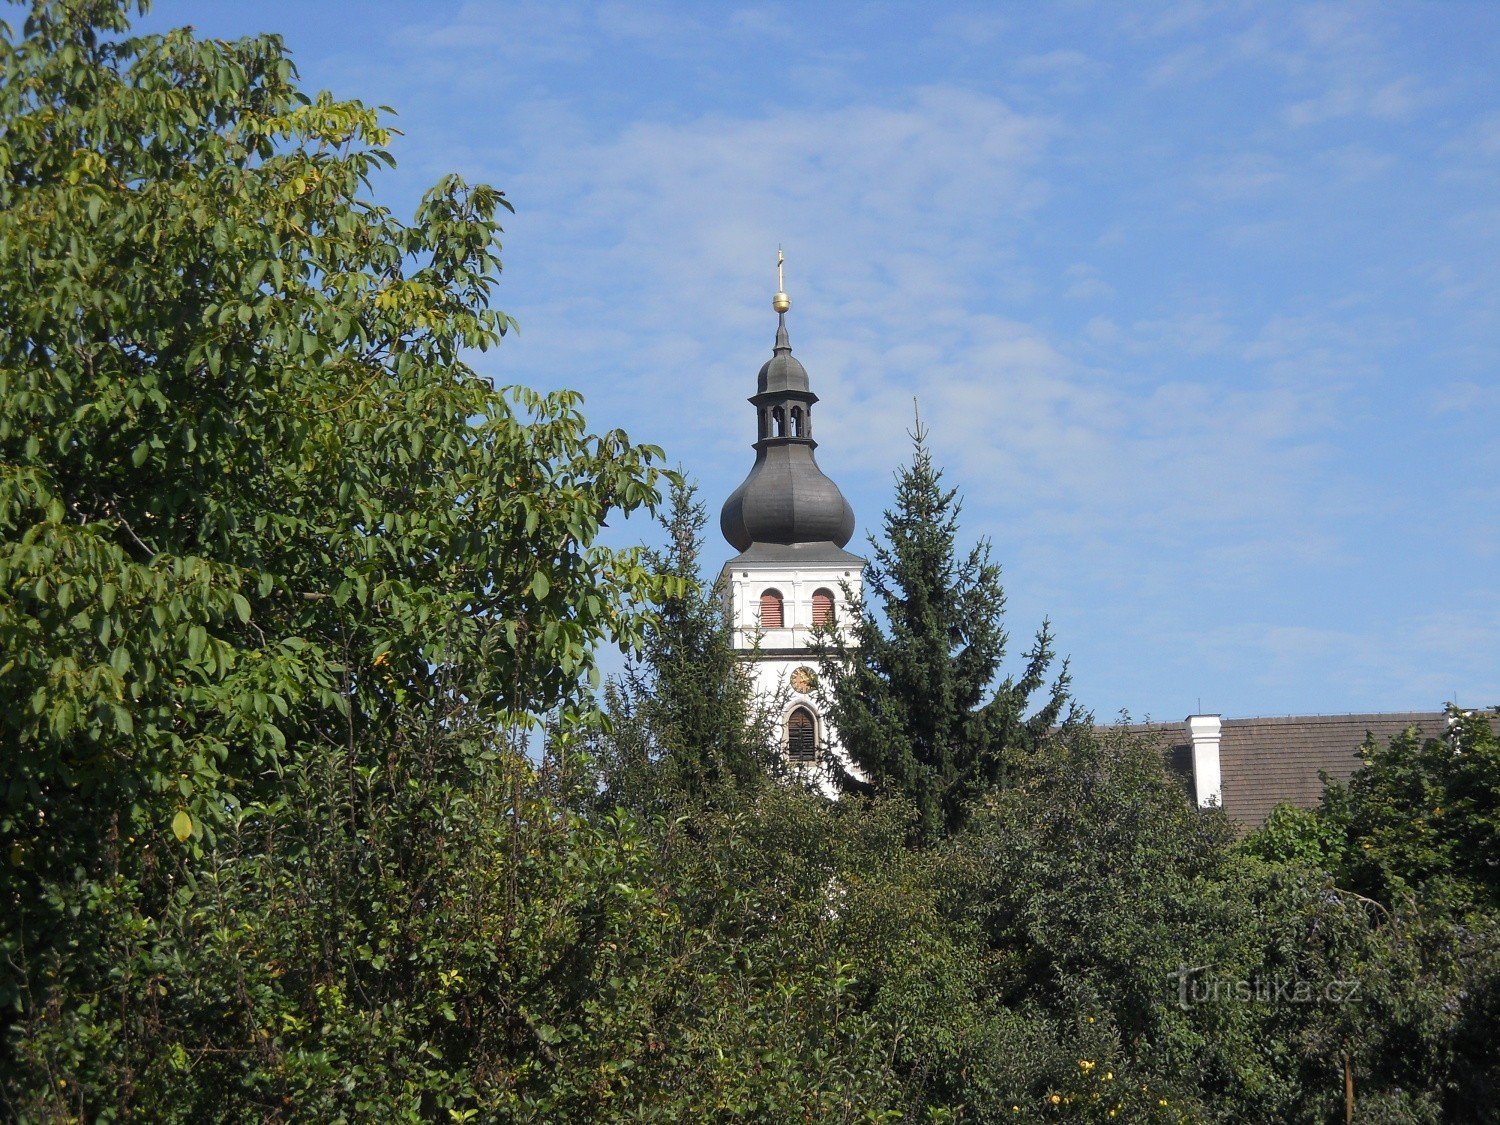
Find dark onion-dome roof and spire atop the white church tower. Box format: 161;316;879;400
719;304;864;566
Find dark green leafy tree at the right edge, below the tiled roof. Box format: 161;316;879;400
1244;713;1500;1122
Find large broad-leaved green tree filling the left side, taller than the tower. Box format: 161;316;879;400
0;0;665;1074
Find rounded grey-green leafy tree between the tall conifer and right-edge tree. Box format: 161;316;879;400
932;728;1464;1122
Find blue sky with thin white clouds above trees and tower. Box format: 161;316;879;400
147;0;1500;719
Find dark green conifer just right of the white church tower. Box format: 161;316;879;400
824;425;1074;839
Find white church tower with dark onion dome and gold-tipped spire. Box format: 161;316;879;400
719;251;864;780
